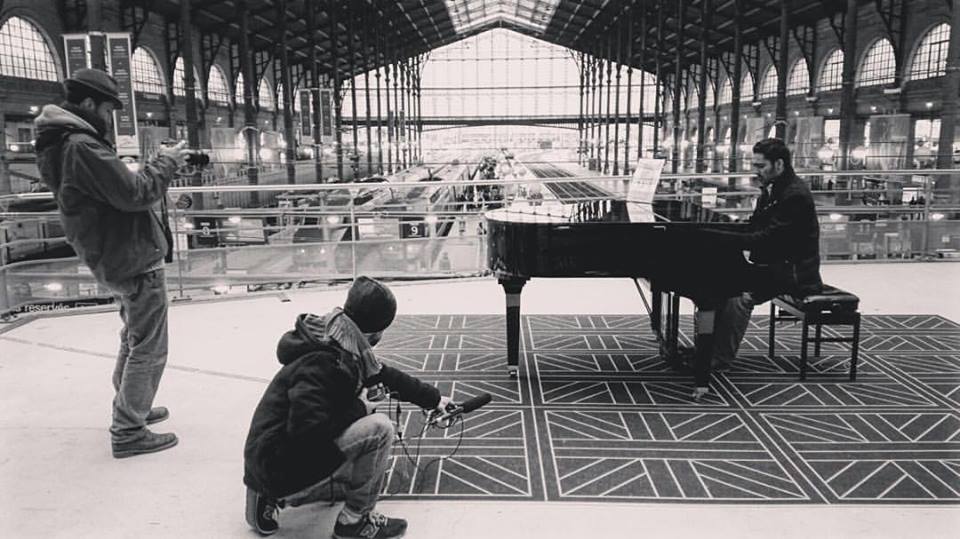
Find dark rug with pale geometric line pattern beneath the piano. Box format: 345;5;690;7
377;311;960;504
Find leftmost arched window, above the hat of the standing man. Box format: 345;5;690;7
0;17;60;82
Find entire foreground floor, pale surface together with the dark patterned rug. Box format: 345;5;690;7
0;264;960;538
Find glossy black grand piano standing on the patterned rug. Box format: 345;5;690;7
485;162;750;386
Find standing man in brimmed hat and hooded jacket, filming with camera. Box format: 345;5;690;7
35;69;186;458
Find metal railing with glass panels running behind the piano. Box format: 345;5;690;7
0;170;960;313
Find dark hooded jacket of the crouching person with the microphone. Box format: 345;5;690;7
243;314;440;498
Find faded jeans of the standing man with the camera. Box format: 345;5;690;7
110;269;167;443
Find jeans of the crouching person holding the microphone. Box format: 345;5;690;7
284;413;394;515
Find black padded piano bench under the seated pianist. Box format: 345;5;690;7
769;285;860;381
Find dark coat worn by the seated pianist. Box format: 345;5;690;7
722;171;823;301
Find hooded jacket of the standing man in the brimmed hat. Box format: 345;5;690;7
35;105;177;291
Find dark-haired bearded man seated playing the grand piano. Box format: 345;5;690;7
694;139;823;398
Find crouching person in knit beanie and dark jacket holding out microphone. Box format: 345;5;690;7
243;276;450;539
